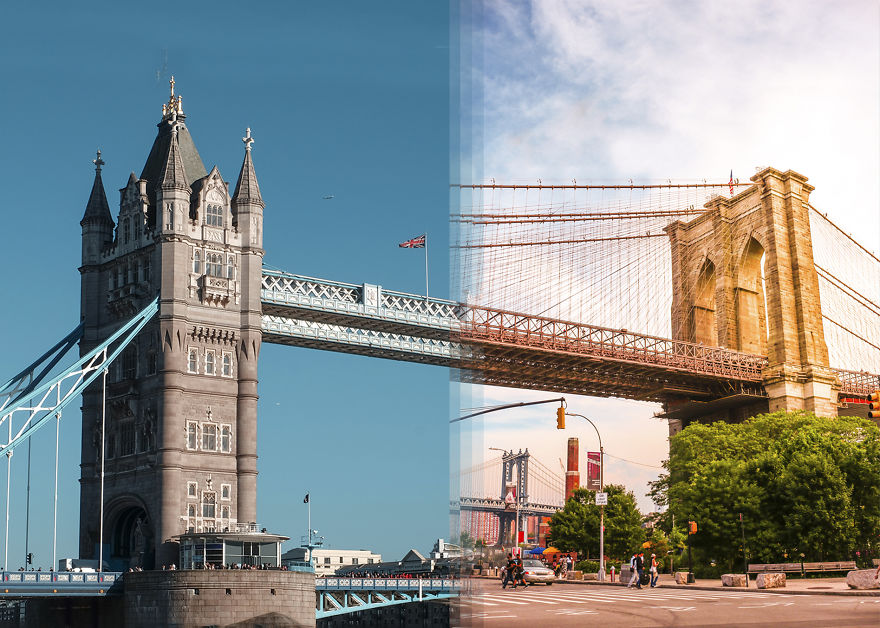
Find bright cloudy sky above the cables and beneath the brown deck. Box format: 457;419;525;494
461;0;880;510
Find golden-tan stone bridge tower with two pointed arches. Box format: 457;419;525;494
667;168;837;416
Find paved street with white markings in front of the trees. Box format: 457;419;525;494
456;580;880;628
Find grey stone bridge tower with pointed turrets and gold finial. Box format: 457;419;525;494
80;79;264;568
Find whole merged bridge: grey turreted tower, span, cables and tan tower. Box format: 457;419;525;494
0;82;880;580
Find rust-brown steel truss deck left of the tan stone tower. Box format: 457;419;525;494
459;307;766;401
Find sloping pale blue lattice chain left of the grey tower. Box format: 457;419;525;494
0;298;159;456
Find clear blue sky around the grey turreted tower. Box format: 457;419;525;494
0;1;449;568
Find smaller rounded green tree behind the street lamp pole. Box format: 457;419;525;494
547;484;645;558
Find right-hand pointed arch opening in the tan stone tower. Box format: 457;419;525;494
736;238;767;355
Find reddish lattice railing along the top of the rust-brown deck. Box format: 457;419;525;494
457;305;767;382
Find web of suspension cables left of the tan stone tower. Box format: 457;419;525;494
452;182;742;338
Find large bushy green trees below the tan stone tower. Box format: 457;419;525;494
651;412;880;567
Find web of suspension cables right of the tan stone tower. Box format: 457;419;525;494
810;208;880;373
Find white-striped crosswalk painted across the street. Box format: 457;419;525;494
459;587;797;612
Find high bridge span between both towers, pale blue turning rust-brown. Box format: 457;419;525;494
261;269;880;402
